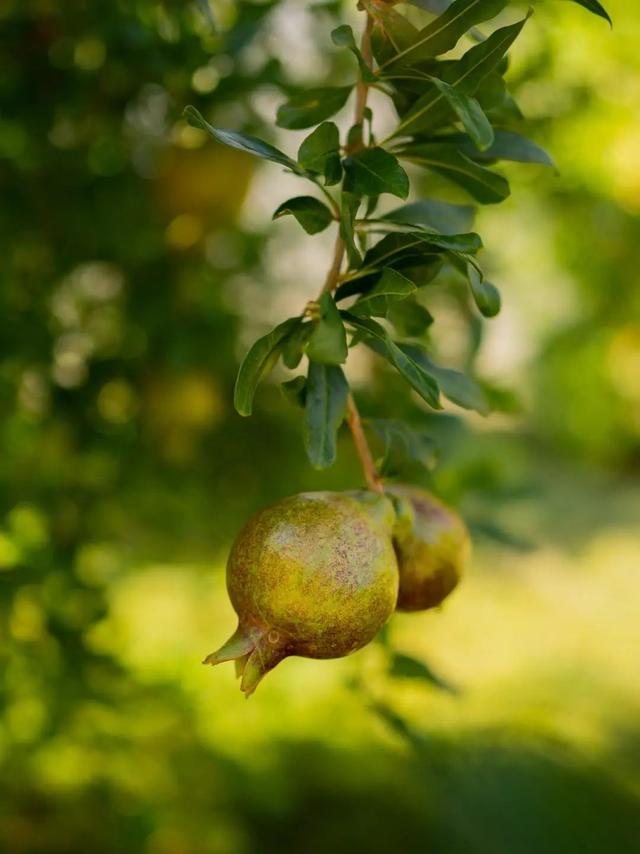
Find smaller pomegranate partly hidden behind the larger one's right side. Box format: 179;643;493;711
388;486;471;611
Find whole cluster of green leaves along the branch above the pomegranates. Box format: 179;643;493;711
186;0;608;468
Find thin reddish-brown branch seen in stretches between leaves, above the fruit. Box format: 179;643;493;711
318;12;384;492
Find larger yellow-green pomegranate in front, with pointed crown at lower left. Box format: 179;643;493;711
204;492;398;695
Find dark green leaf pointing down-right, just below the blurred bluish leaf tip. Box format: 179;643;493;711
397;143;511;205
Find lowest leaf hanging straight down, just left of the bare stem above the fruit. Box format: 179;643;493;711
304;361;349;469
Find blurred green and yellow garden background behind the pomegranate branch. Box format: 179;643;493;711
0;0;640;854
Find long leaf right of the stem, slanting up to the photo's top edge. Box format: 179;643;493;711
383;0;508;67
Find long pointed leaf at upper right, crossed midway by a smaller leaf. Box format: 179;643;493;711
394;16;528;136
